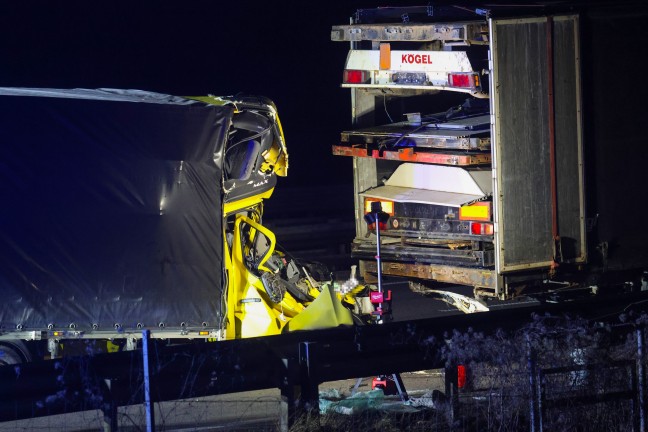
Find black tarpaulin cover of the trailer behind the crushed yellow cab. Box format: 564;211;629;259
0;88;232;334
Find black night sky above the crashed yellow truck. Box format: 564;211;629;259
0;0;392;195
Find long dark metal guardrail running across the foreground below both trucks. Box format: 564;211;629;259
0;293;648;430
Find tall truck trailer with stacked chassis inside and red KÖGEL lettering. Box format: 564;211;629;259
331;2;648;300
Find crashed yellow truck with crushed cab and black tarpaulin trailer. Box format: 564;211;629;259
0;88;353;364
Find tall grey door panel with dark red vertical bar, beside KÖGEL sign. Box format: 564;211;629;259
490;16;586;273
